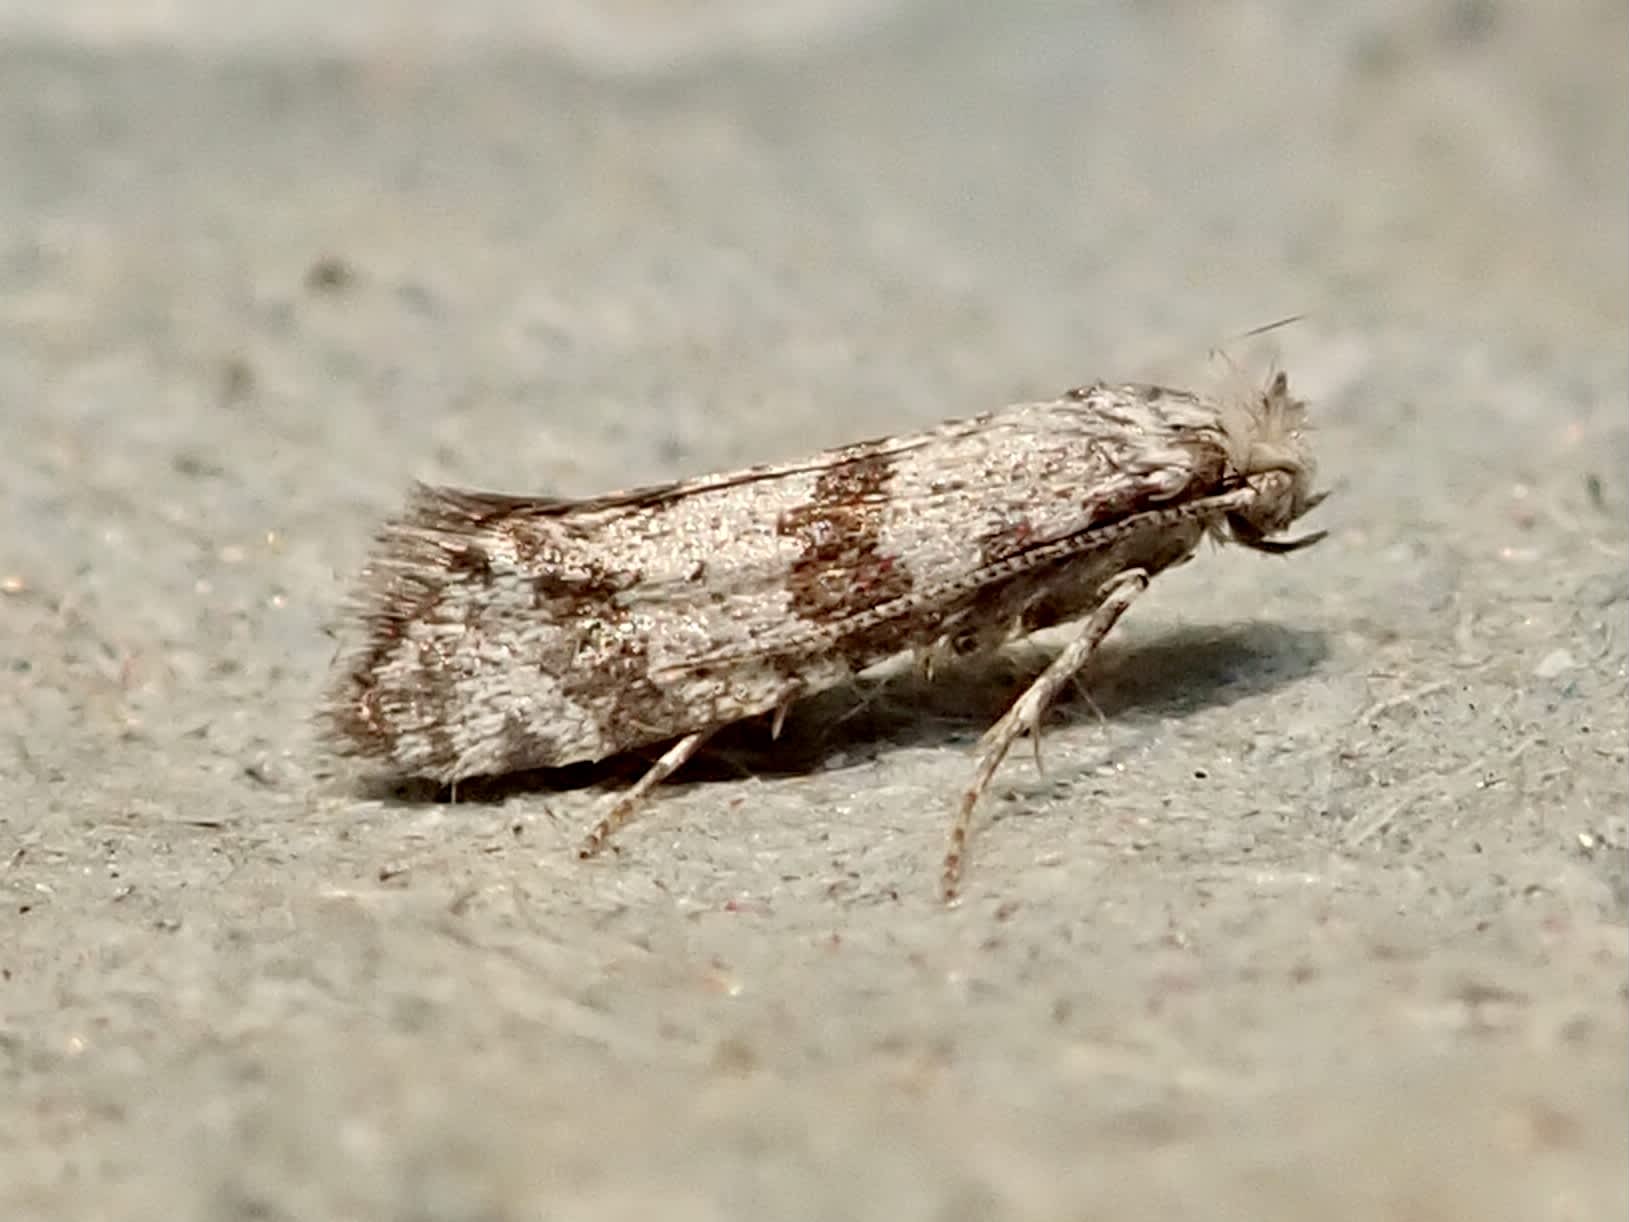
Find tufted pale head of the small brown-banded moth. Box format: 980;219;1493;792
1223;371;1329;554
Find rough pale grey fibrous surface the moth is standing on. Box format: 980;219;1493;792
0;0;1629;1222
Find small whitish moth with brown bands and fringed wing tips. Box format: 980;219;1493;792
321;373;1324;899
